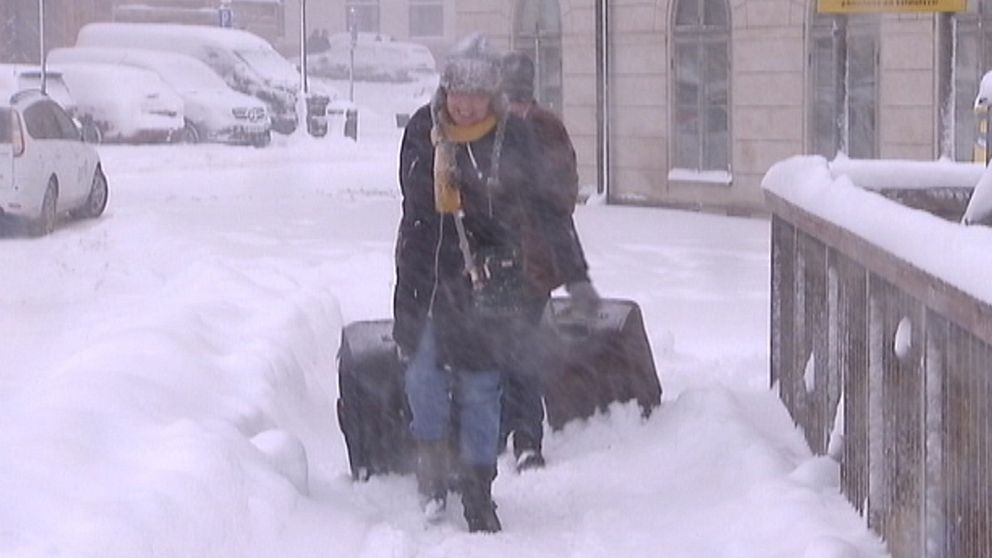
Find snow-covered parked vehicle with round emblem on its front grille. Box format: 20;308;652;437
48;47;272;147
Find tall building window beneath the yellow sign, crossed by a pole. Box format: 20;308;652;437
808;13;879;159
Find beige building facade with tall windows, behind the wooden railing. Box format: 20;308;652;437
456;0;992;213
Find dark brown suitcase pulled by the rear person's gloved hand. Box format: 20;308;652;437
542;297;661;430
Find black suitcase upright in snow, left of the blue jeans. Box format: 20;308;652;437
337;320;414;480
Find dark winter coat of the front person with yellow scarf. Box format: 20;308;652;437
393;101;585;370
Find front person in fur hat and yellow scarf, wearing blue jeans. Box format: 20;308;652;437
393;35;596;532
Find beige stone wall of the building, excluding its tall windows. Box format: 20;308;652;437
456;0;940;214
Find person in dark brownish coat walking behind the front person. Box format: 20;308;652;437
500;52;599;471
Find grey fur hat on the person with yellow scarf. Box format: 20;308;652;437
440;33;500;95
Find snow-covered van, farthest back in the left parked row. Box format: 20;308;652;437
76;23;300;134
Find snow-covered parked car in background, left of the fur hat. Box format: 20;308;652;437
294;33;437;84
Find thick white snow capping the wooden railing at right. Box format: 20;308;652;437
761;156;992;310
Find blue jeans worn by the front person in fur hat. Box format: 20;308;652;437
406;321;502;465
